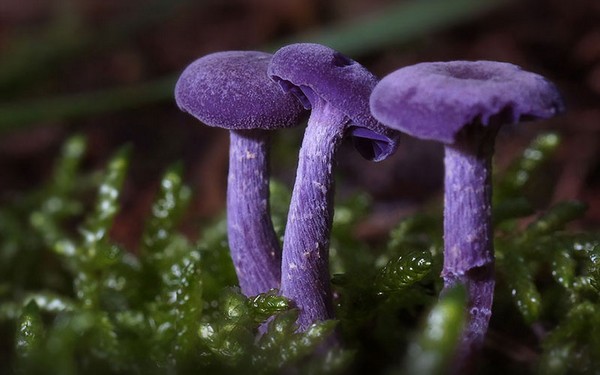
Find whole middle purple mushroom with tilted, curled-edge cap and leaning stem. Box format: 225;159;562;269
269;44;399;331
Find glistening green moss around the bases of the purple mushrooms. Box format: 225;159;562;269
0;134;600;374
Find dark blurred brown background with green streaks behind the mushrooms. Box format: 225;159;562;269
0;0;600;249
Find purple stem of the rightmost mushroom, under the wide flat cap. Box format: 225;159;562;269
442;126;497;366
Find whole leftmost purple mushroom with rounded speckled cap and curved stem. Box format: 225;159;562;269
175;51;304;296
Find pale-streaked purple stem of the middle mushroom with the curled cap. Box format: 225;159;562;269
281;98;348;331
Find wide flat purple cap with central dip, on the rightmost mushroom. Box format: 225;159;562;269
371;61;564;144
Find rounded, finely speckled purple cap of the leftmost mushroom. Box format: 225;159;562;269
175;51;304;130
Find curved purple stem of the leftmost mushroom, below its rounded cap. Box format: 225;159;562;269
227;130;281;296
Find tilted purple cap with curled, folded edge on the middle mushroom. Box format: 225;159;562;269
268;43;400;161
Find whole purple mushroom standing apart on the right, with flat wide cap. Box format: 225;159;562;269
371;61;563;361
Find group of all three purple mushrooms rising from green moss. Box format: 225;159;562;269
175;47;563;367
